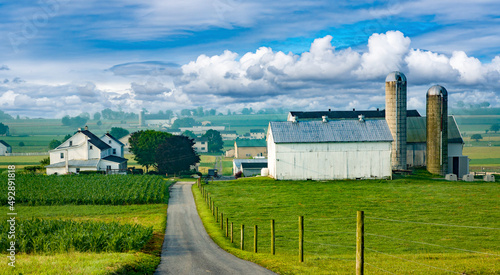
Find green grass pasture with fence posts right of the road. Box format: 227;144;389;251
193;177;500;274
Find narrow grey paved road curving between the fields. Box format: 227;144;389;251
155;182;275;275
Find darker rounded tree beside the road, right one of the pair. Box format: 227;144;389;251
156;136;200;174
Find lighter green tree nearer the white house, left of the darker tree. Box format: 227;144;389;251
129;130;172;171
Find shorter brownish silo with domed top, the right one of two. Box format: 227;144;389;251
425;85;448;175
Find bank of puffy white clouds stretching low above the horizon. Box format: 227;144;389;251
0;31;500;117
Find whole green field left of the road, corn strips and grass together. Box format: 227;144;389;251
0;174;172;274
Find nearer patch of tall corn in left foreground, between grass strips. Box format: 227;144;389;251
0;219;153;253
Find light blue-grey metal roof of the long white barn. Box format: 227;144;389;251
269;119;393;143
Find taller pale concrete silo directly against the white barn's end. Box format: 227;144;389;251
385;72;406;170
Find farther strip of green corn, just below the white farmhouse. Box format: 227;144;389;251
0;174;169;206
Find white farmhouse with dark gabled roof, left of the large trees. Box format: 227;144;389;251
46;127;127;175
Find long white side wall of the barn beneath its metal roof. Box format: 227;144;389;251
268;142;392;180
